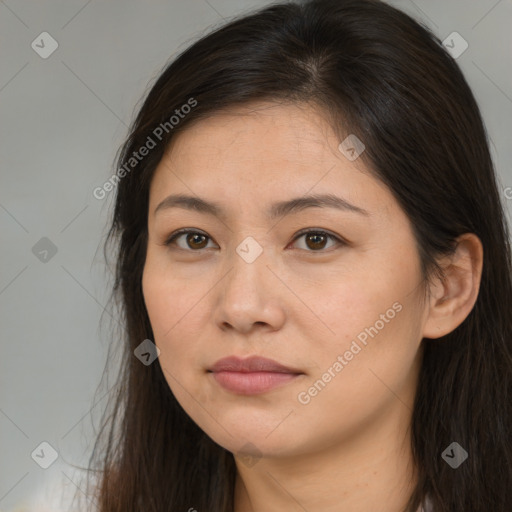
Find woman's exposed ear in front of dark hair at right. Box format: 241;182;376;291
423;233;483;339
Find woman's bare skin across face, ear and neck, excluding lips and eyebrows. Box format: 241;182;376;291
143;103;482;512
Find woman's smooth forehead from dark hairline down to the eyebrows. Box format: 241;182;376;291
151;103;392;222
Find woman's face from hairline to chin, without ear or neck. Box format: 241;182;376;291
142;104;426;457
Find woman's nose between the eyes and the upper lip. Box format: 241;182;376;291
214;244;285;334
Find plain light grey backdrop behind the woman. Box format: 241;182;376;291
0;0;512;512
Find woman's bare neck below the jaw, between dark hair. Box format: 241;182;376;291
234;400;416;512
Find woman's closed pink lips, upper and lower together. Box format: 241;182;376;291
209;356;302;395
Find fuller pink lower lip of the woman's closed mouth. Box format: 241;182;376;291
213;371;299;395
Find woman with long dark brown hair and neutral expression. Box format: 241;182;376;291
76;0;512;512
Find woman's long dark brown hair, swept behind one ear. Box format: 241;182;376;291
74;0;512;512
